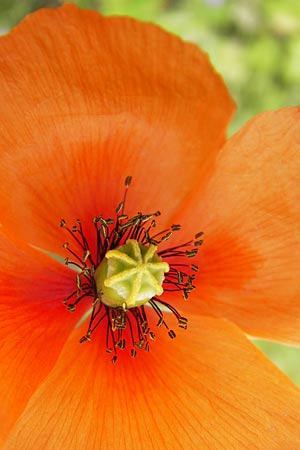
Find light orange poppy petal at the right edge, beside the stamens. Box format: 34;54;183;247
180;108;300;344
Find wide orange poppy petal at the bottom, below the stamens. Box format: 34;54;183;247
6;317;300;450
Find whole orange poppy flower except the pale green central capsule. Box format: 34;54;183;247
0;5;300;450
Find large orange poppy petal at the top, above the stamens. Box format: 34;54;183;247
0;5;233;252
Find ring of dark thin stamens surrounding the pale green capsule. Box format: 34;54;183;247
60;177;203;363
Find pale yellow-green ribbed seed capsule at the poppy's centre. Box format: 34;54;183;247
94;239;169;308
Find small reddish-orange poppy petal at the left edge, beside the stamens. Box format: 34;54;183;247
0;235;78;442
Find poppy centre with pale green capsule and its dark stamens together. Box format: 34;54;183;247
61;177;203;363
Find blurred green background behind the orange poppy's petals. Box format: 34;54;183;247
0;0;300;384
